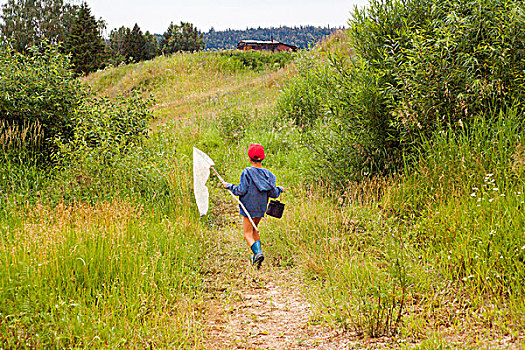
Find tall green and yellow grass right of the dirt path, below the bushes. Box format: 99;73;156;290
256;111;525;346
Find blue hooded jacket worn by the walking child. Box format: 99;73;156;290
226;167;283;218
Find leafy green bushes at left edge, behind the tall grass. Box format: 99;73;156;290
0;43;152;204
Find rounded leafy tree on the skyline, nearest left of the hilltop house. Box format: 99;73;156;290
161;22;204;54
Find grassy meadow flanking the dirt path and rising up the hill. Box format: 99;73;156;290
0;12;525;349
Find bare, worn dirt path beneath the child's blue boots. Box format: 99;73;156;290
201;229;355;349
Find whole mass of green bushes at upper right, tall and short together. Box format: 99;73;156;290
279;0;525;185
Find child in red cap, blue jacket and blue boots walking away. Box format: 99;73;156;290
222;144;283;268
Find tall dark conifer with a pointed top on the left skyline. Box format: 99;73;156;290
65;3;105;74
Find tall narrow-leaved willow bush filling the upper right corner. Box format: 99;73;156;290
358;0;525;147
